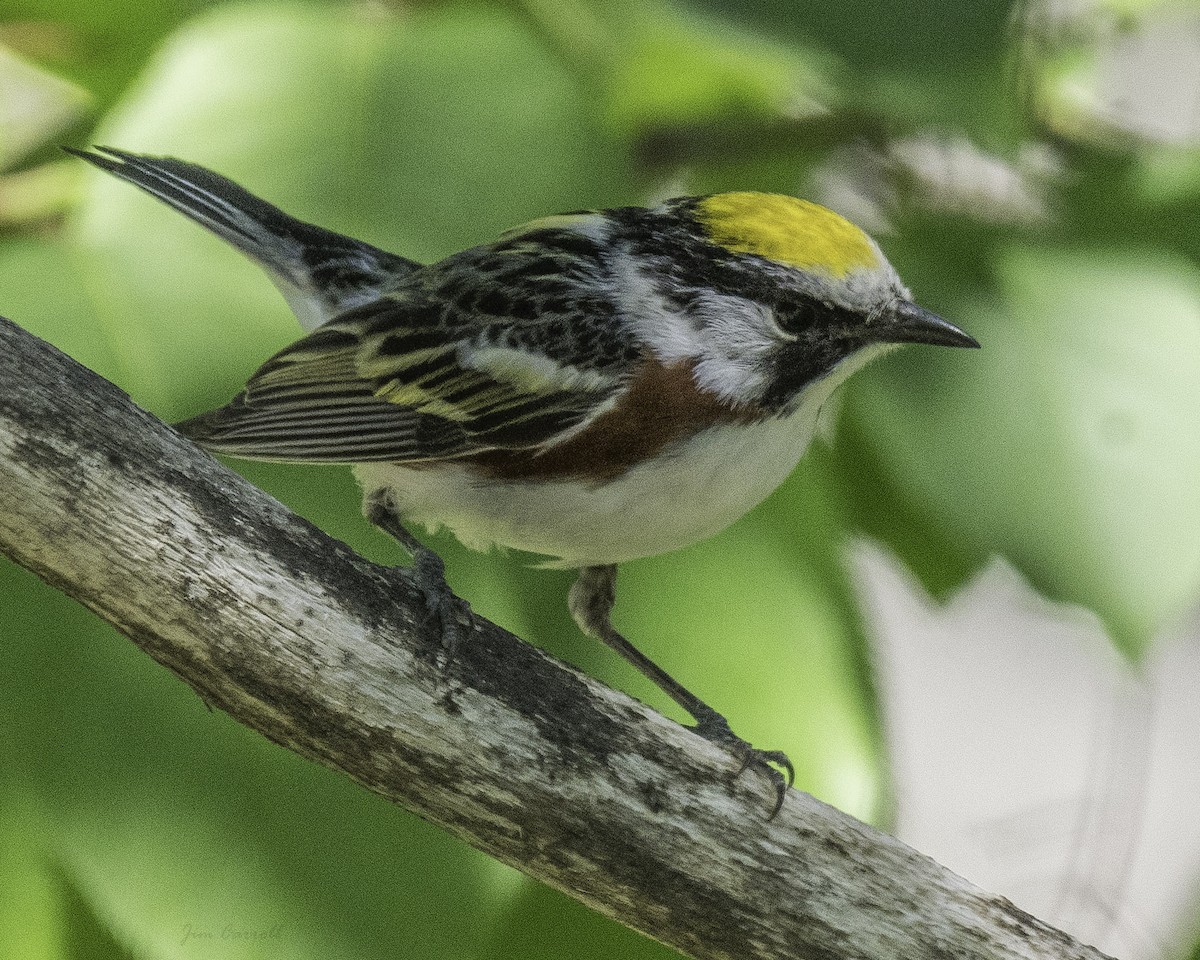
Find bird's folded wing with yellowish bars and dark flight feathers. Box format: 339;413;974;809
178;276;628;463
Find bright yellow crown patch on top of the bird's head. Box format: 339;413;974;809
696;191;880;280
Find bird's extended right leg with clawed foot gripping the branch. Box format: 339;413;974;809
569;565;796;820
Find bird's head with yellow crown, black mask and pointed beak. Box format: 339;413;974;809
631;192;979;410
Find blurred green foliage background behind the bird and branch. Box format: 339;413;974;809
0;0;1200;960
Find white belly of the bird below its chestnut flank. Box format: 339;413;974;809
355;415;815;566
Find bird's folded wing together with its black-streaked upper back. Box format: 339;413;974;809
180;225;637;463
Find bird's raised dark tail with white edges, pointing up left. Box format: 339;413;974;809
64;146;420;330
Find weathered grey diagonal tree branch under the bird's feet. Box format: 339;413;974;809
0;319;1102;960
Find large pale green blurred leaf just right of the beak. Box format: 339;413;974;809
853;248;1200;655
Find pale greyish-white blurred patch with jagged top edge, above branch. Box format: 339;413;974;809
853;545;1200;960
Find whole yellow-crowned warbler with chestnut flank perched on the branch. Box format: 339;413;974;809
71;148;979;816
